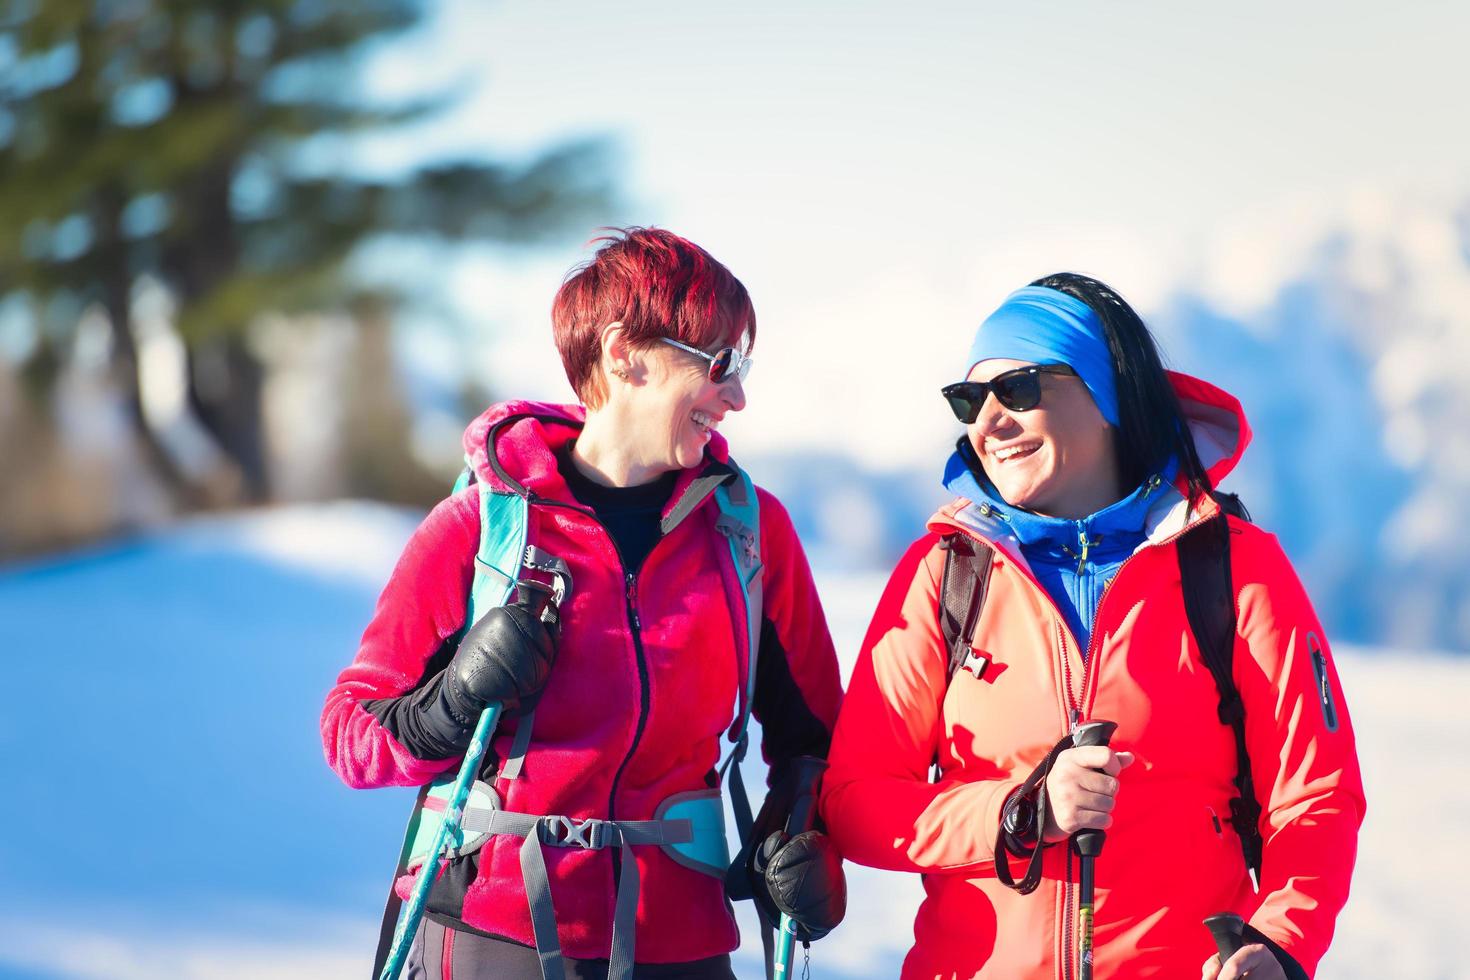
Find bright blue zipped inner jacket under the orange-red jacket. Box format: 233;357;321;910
944;453;1177;657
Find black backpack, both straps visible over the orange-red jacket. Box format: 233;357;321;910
939;492;1263;882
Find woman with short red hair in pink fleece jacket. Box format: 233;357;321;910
322;228;844;980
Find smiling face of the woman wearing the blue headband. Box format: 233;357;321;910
966;359;1122;520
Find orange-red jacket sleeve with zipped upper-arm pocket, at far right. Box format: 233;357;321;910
1232;522;1364;974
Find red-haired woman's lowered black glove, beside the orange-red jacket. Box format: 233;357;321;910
756;830;847;942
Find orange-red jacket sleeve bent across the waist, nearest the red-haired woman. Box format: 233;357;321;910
822;533;1019;871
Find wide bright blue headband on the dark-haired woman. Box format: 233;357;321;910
964;287;1117;425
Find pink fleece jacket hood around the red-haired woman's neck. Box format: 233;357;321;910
465;401;729;500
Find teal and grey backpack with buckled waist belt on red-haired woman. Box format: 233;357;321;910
373;416;763;976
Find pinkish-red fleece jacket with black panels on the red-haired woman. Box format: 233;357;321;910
322;403;841;962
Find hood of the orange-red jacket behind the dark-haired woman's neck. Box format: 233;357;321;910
929;372;1251;549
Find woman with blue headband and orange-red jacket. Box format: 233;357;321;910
822;273;1364;980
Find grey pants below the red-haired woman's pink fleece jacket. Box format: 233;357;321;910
403;918;735;980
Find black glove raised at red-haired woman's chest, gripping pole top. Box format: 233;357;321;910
440;583;559;727
